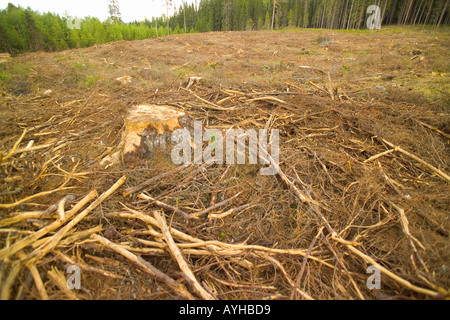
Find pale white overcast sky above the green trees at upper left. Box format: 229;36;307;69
0;0;194;22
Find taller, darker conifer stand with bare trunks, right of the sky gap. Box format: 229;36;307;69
177;0;450;32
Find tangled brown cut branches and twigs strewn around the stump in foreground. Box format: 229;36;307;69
0;80;450;300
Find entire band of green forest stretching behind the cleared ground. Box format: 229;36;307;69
0;0;450;55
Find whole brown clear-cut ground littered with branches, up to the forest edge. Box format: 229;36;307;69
0;27;450;299
